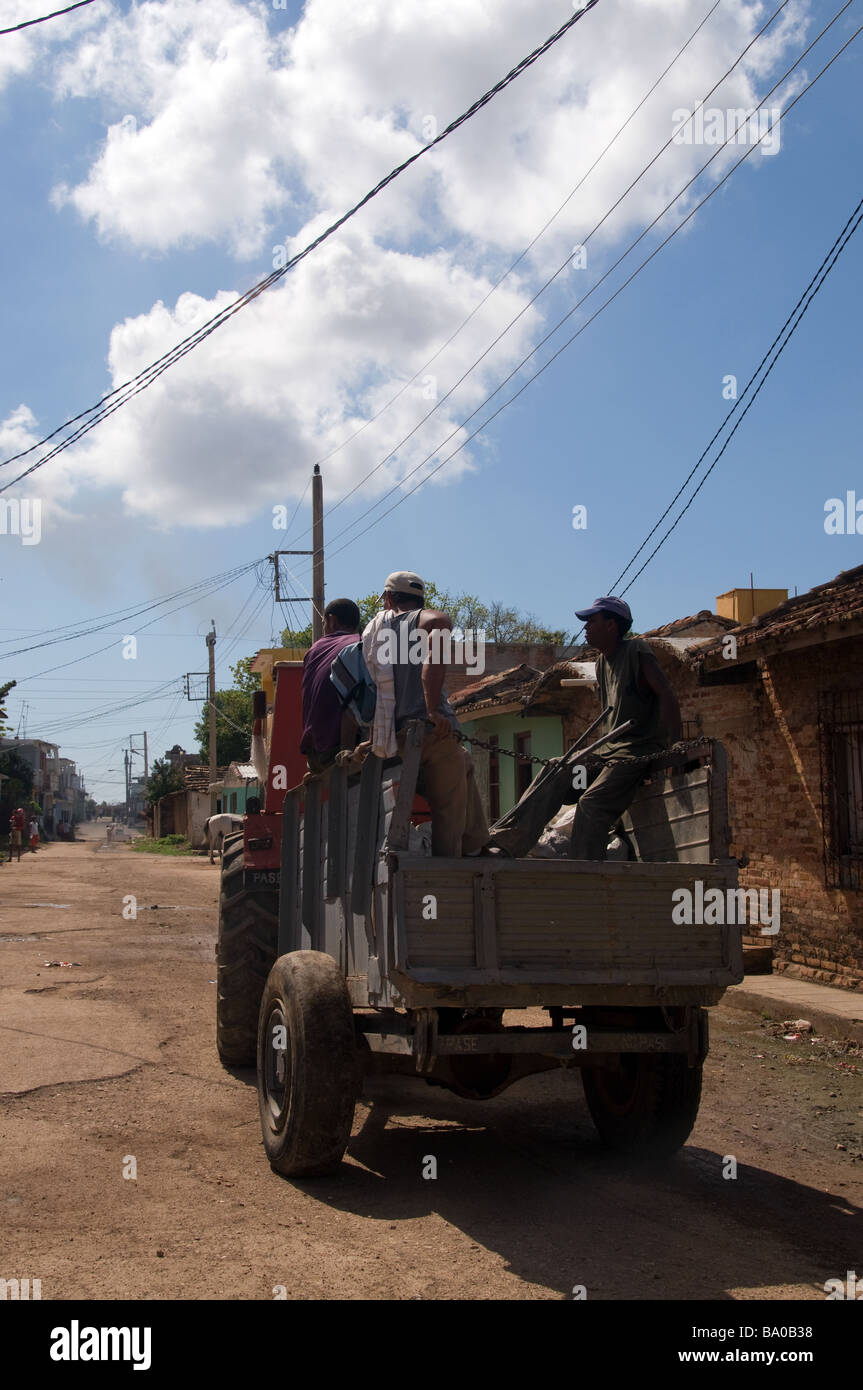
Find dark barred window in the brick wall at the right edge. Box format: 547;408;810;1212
819;691;863;892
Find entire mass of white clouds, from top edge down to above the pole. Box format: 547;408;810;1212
11;0;803;525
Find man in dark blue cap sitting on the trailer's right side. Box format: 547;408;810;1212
570;596;681;859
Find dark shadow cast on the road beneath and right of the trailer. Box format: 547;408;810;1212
277;1077;862;1300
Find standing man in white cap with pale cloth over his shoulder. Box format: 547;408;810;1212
364;570;488;859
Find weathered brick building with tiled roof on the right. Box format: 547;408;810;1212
508;566;863;991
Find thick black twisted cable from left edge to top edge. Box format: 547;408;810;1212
0;0;599;492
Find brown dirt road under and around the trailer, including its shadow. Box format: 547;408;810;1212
0;826;863;1300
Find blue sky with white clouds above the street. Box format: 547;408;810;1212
0;0;863;799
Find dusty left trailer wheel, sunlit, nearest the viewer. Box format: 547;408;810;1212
257;951;360;1177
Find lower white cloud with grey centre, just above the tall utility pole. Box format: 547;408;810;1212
65;232;536;525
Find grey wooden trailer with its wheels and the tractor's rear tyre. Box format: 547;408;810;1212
217;695;743;1177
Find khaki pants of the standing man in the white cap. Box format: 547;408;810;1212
397;730;488;859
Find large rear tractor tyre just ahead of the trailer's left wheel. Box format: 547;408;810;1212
215;831;279;1066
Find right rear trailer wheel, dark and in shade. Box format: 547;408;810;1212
581;1052;702;1158
